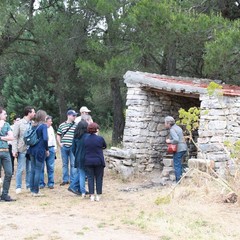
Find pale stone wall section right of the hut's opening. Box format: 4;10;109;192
198;95;240;170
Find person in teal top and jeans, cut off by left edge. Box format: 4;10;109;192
0;107;14;202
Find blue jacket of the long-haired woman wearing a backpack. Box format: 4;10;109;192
27;123;48;162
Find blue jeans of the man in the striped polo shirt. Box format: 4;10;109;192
61;146;77;183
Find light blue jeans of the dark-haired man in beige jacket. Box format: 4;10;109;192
16;152;31;188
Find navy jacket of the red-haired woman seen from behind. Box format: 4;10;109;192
84;133;107;167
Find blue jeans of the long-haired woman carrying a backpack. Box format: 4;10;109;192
30;155;43;193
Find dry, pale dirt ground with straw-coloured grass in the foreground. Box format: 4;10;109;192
0;160;240;240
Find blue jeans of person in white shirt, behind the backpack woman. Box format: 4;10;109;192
39;147;55;187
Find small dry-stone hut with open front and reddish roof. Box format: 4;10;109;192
106;71;240;177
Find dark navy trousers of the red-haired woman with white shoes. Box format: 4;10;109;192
86;166;104;194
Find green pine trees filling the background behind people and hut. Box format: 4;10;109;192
0;0;240;144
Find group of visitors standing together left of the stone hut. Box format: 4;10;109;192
0;106;107;202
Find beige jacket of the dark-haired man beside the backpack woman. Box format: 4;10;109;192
12;118;30;153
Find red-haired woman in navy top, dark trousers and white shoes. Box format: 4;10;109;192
84;122;107;201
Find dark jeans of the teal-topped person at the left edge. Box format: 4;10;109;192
0;152;12;198
